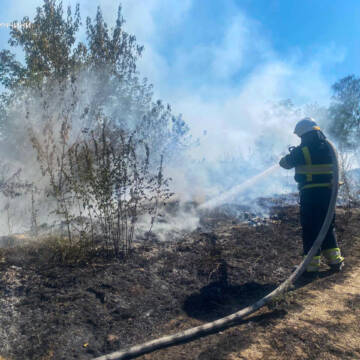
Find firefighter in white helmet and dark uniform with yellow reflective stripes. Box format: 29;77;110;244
279;118;344;277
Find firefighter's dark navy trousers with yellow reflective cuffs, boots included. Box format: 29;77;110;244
300;187;344;272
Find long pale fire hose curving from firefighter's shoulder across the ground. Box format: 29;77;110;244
94;141;339;360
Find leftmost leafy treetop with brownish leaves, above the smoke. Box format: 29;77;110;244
0;0;85;89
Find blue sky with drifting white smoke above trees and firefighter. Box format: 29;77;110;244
0;0;360;156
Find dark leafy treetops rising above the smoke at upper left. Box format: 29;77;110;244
0;0;143;88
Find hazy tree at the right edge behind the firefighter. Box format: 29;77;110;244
329;75;360;149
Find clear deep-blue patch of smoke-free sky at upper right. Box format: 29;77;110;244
238;0;360;81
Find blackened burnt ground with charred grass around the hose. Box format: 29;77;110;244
0;202;360;360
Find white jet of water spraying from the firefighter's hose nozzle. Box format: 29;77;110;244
199;164;280;210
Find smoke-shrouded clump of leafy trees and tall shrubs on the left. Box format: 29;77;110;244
0;0;188;254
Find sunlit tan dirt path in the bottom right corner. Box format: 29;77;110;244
228;268;360;360
